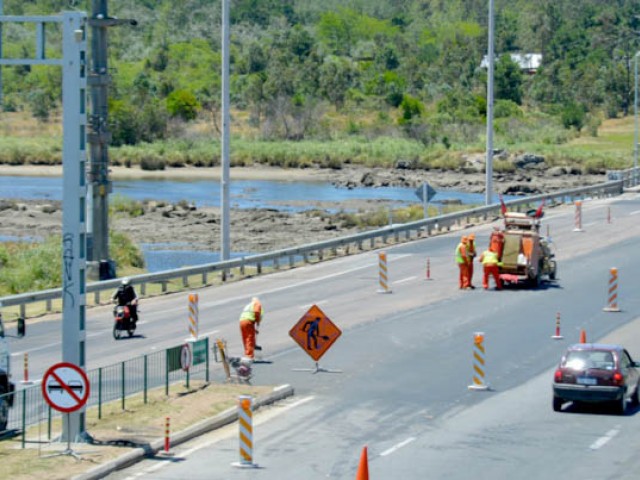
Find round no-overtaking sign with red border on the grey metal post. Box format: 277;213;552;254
42;362;90;413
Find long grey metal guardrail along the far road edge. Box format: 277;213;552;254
0;168;640;318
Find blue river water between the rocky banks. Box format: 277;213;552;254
0;176;513;272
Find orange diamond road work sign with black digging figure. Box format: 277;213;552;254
289;305;342;362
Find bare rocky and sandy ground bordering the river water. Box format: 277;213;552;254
0;166;605;252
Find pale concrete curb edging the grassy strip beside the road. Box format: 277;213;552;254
72;385;294;480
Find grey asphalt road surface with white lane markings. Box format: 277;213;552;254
11;189;640;479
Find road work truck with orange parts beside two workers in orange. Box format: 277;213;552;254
489;209;557;287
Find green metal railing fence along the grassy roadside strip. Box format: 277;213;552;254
0;338;211;448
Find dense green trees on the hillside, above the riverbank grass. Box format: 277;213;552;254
3;0;640;146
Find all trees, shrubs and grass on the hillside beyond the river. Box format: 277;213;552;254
0;0;640;170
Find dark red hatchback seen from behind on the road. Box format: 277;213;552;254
553;343;640;415
